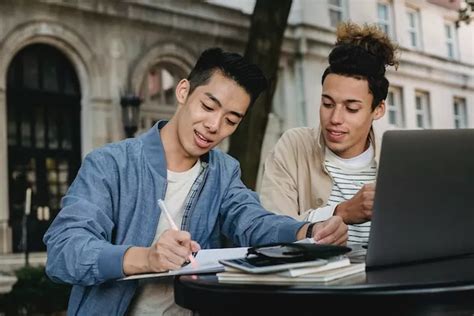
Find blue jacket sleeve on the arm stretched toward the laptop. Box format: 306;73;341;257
220;164;305;246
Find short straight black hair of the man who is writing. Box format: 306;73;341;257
188;48;268;105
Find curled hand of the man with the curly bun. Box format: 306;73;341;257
334;183;375;224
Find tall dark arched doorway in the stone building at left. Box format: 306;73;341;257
7;44;81;252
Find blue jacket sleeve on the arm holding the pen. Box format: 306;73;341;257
43;152;130;286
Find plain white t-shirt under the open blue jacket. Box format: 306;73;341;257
129;160;201;316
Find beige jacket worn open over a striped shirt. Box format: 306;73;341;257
260;127;380;220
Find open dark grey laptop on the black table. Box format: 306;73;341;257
365;129;474;268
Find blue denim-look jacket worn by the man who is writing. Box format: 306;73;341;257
44;122;304;315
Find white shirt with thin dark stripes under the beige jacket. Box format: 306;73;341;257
324;146;377;245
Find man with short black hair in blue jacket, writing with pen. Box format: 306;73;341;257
44;48;347;315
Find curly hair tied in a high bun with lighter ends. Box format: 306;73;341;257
321;22;398;110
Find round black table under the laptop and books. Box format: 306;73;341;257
174;256;474;316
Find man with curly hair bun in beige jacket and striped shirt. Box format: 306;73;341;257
261;22;398;245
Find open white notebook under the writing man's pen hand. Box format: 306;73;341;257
119;247;248;281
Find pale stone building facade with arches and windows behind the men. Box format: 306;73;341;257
0;0;474;253
